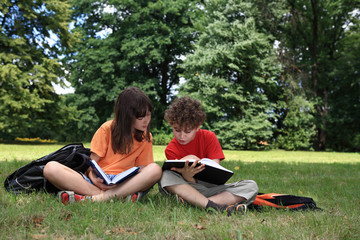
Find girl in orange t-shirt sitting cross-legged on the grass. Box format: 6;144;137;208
44;87;162;204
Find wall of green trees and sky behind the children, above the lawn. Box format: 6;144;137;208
0;0;360;151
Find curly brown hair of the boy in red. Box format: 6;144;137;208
164;96;206;130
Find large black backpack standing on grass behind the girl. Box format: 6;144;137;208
4;143;90;194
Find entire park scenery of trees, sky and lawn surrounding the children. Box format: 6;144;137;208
0;0;360;240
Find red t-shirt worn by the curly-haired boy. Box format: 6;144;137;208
165;129;225;160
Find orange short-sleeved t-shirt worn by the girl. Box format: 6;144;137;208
90;120;154;174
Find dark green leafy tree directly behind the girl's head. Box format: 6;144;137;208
68;0;201;138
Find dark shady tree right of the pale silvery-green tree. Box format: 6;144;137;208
254;0;360;150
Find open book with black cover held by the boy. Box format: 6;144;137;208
162;158;234;185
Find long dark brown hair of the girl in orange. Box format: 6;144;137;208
111;87;153;154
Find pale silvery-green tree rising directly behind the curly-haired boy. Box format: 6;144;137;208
180;0;278;149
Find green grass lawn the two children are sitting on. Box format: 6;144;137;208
0;144;360;239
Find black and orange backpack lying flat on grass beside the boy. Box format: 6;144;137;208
249;193;321;211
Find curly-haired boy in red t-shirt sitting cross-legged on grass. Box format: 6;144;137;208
159;97;258;216
